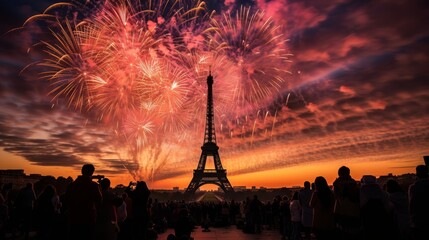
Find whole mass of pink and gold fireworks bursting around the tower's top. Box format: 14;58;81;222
24;0;289;180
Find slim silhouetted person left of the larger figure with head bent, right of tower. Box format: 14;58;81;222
299;181;313;239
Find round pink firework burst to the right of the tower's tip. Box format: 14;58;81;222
206;7;290;109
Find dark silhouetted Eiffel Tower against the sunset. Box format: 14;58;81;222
186;73;234;193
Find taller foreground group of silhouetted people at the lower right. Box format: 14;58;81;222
274;165;429;240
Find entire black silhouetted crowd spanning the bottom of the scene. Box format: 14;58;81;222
0;164;429;240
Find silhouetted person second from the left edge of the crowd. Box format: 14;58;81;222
16;183;36;239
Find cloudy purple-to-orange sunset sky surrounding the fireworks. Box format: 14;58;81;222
0;0;429;189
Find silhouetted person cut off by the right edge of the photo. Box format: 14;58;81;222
408;165;429;240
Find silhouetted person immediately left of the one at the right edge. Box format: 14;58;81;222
386;179;411;240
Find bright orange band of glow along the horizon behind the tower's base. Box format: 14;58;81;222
0;147;423;190
